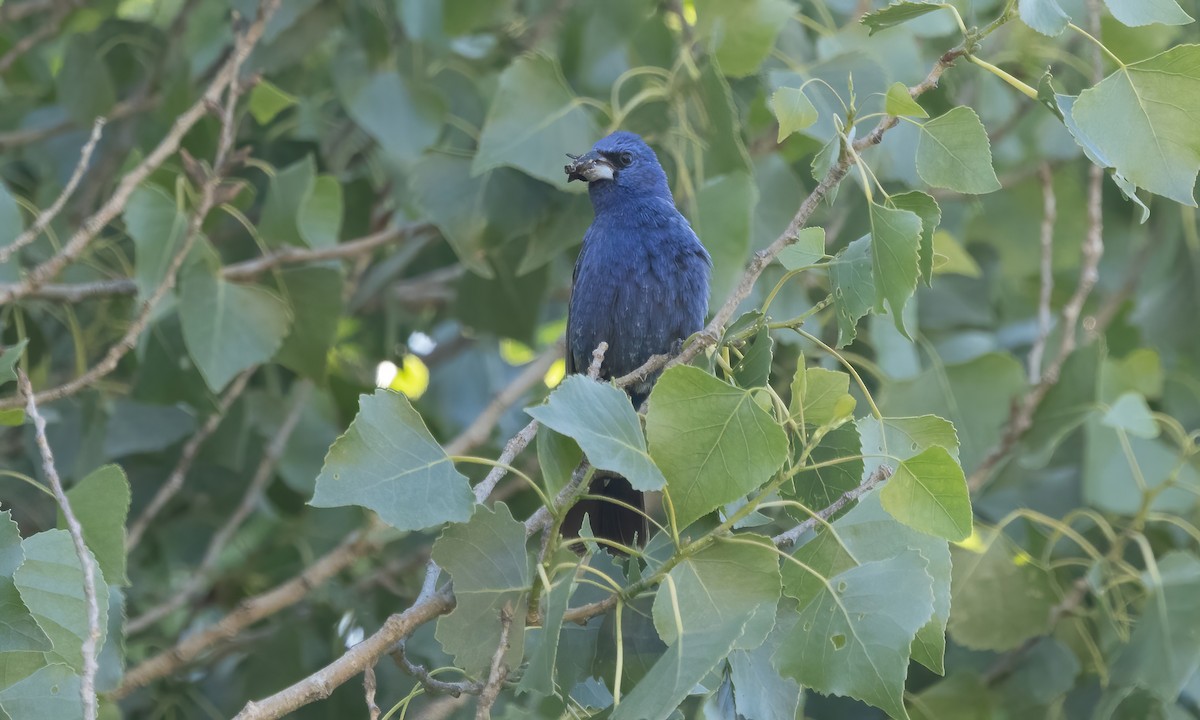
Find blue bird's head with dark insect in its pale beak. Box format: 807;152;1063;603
563;131;671;198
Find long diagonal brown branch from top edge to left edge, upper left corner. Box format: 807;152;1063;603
0;0;281;305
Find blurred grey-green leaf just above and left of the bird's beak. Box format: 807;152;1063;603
470;54;599;187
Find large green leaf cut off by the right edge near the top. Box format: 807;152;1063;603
1070;46;1200;208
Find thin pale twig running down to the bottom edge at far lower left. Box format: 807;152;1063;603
17;367;101;720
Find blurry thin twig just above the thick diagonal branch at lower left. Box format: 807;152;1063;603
126;380;312;635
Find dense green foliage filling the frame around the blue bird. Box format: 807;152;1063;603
0;0;1200;720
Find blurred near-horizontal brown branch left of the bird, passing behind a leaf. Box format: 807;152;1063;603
0;222;436;302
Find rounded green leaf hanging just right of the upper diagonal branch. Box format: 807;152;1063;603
917;106;1000;194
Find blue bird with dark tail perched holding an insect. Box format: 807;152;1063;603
563;132;713;546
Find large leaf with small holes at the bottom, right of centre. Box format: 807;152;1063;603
774;552;934;720
